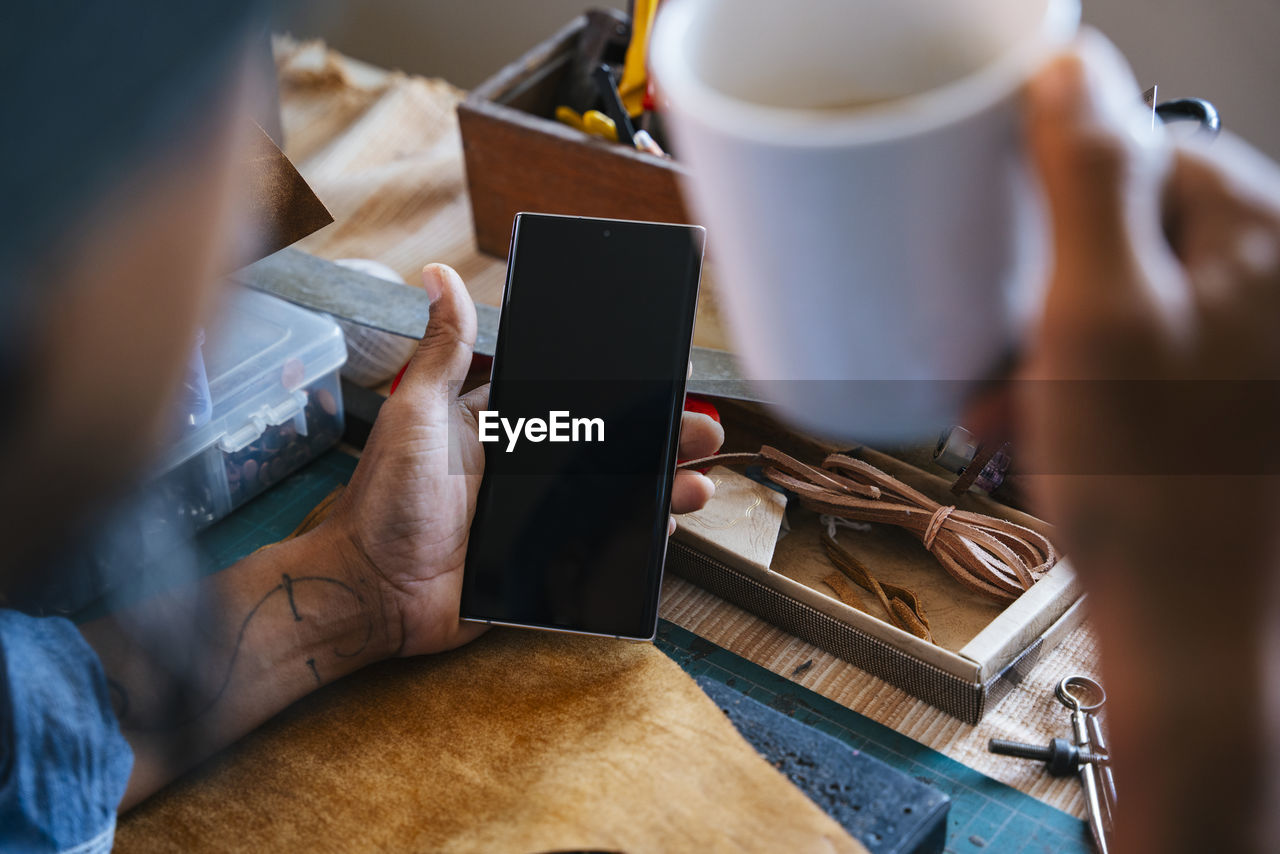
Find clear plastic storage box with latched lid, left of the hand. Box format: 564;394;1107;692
156;289;347;530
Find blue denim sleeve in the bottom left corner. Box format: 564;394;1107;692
0;611;133;854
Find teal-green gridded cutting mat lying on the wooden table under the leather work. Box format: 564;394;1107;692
200;451;1093;854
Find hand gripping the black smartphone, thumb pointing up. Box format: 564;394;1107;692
317;264;724;656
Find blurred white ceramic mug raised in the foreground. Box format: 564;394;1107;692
649;0;1080;440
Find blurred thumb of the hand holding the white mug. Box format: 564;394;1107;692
1027;31;1167;290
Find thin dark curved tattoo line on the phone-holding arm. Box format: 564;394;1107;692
108;574;374;732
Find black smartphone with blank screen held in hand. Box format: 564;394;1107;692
462;214;704;640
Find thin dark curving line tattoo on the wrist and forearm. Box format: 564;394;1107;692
108;574;375;732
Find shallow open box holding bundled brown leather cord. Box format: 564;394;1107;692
667;401;1083;725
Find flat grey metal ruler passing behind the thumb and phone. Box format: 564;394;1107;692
232;248;763;402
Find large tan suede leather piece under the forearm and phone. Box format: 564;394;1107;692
116;629;865;854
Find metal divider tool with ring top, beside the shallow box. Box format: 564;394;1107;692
987;676;1116;854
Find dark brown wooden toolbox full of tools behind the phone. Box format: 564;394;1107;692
458;17;691;257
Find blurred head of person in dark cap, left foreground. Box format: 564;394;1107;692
0;0;260;583
